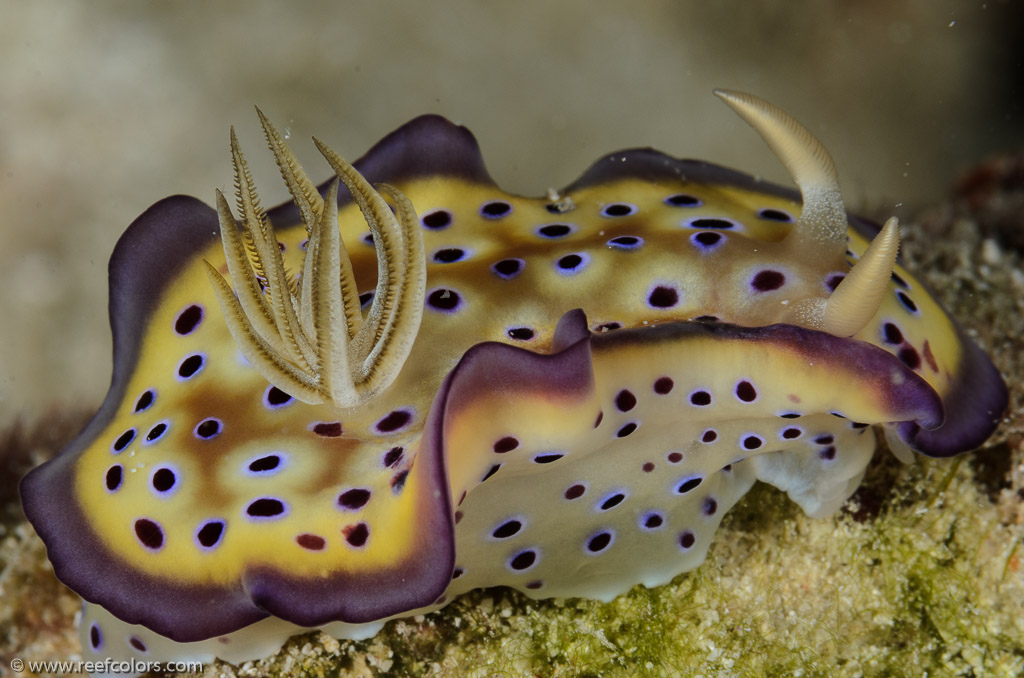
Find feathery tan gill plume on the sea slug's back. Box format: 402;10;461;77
206;109;426;408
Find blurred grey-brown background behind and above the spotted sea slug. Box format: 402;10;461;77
0;0;1024;424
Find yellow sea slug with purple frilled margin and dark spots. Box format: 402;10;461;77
22;91;1007;662
